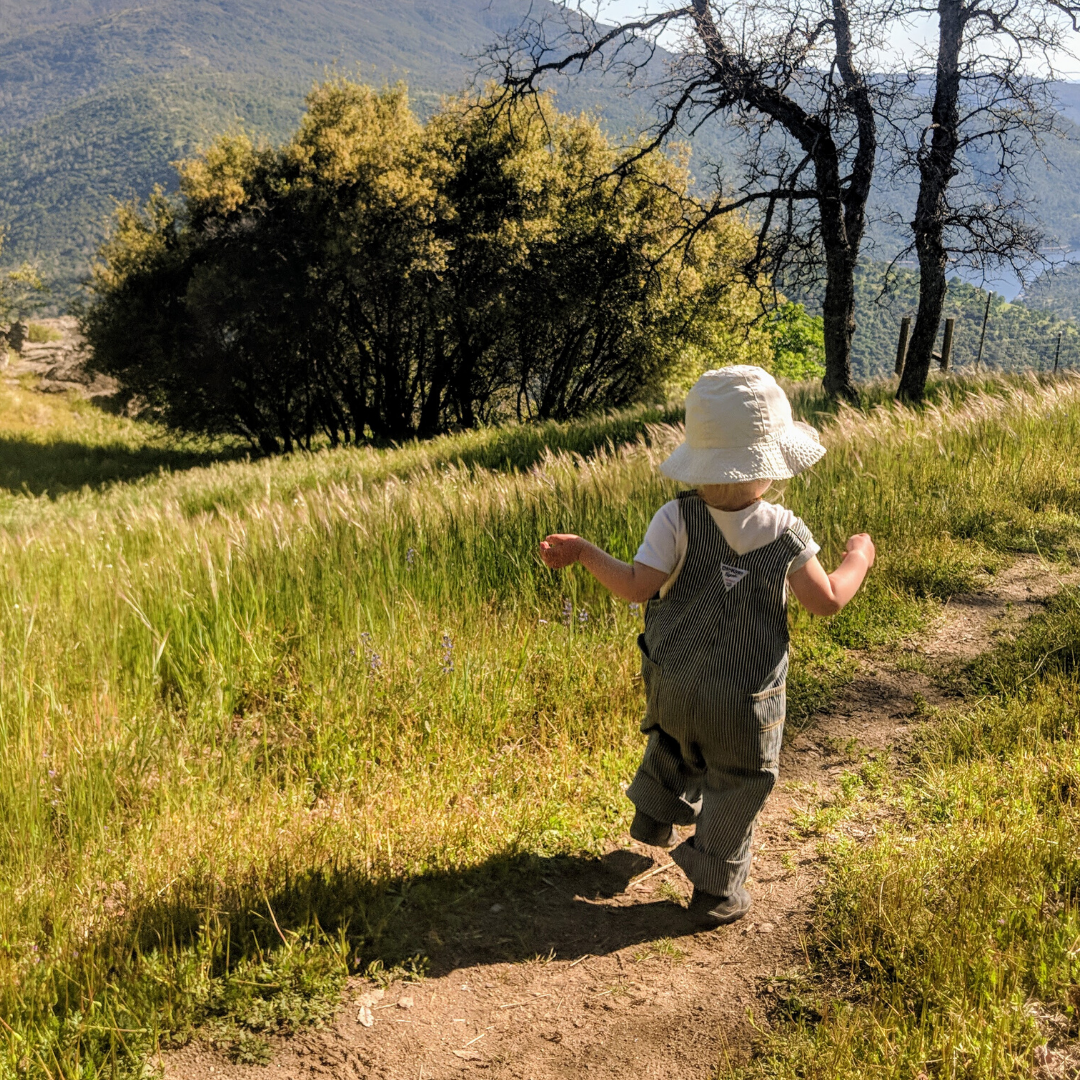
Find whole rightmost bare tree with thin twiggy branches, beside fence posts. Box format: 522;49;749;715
893;0;1080;401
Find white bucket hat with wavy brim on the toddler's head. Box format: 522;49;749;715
660;364;825;484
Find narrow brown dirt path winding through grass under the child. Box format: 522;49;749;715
164;557;1080;1080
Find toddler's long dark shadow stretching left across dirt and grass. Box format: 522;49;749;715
132;850;691;975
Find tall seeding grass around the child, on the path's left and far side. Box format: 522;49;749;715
0;380;1080;1077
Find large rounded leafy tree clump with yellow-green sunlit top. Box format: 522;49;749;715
82;79;769;451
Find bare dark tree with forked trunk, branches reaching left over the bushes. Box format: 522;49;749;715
487;0;888;400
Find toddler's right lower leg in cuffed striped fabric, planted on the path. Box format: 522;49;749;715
672;769;777;896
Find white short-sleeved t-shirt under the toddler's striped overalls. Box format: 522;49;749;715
634;499;821;595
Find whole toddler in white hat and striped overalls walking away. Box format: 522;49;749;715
540;366;875;927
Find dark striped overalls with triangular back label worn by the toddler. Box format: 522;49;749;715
626;491;810;896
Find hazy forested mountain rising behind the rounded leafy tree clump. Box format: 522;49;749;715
6;0;1080;319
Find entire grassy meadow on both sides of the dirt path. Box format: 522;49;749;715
0;376;1080;1078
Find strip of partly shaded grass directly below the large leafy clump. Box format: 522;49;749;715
0;395;683;528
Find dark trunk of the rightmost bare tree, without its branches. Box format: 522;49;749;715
896;0;964;402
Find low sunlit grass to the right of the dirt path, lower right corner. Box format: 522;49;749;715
743;590;1080;1080
